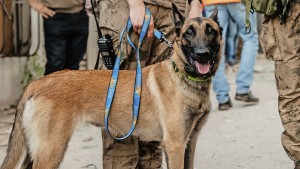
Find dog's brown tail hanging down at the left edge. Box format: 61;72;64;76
1;97;27;169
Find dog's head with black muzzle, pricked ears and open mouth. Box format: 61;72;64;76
172;4;223;78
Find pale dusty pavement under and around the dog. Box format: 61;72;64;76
0;56;293;169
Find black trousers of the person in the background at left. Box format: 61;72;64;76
44;11;89;75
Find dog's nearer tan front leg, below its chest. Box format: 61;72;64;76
162;139;185;169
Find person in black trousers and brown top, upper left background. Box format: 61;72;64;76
28;0;89;75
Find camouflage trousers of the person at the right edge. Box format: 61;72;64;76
260;1;300;161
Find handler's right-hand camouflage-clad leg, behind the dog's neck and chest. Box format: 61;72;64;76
138;5;176;169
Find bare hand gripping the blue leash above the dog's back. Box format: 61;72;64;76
127;0;154;38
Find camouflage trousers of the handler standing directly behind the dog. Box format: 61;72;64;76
99;0;176;169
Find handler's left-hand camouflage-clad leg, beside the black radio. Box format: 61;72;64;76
99;0;138;169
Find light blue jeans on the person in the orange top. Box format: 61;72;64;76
204;3;258;103
